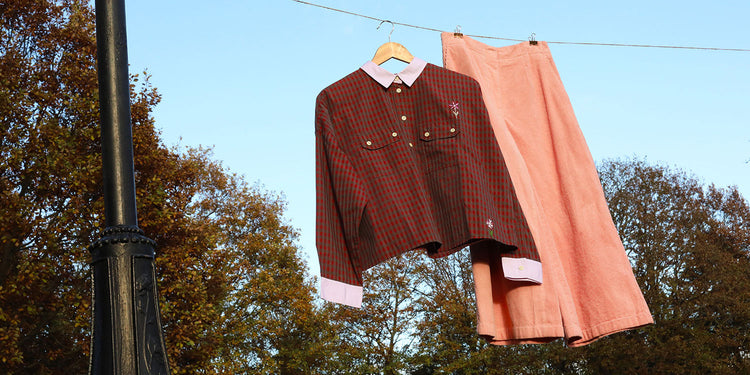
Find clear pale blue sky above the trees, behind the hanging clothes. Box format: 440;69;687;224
120;0;750;280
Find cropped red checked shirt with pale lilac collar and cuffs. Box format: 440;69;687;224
315;58;541;307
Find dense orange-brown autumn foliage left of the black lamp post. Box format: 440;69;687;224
0;1;102;374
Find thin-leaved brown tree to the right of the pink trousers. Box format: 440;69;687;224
587;159;750;374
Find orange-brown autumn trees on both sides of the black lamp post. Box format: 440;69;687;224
0;0;333;374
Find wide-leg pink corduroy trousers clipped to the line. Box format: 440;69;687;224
442;33;653;347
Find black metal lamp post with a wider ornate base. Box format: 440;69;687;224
89;0;169;375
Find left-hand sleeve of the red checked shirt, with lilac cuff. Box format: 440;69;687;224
315;92;367;307
